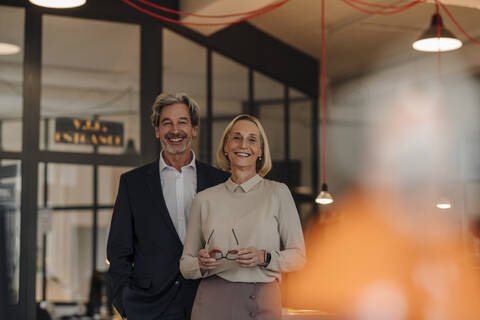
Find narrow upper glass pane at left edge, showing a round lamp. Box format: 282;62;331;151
0;6;25;151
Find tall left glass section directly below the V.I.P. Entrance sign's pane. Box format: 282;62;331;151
37;163;94;302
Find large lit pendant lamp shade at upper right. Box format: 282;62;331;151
412;14;462;52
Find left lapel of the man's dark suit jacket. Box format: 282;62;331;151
147;159;183;248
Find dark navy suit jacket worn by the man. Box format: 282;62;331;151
107;160;229;320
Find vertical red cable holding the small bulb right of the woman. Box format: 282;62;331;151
320;0;327;184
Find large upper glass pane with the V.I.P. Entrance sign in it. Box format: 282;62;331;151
39;15;140;154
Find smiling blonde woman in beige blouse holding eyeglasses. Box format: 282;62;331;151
180;115;305;320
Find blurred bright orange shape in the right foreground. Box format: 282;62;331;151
288;192;480;320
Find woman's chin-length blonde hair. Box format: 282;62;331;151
217;114;272;177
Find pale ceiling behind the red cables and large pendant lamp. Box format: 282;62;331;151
181;0;480;82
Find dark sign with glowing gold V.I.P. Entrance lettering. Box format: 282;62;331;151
55;117;123;147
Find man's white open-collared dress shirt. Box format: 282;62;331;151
159;150;197;243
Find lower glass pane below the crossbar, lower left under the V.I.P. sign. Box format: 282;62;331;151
37;210;92;304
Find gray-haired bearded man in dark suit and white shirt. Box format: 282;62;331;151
107;93;228;320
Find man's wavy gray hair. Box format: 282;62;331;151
151;92;200;128
